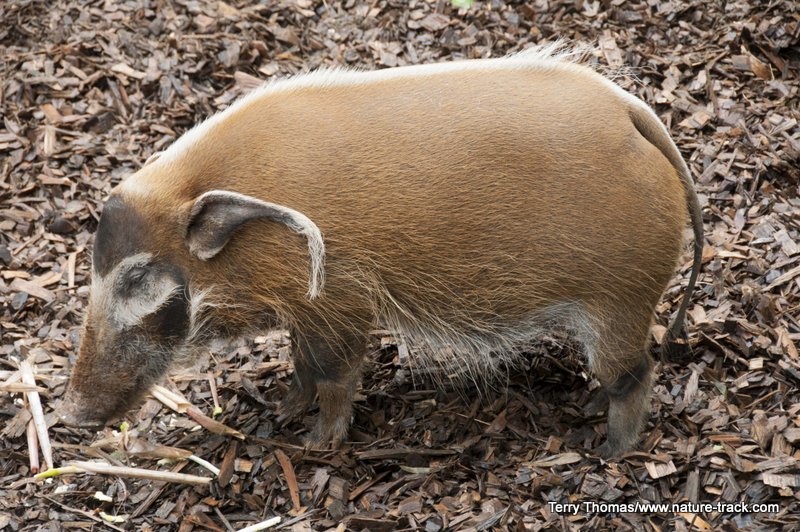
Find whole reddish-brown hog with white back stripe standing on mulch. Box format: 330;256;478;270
61;44;703;456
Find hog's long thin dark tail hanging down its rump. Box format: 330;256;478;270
628;103;704;354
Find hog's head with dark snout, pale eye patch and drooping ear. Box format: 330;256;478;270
59;186;324;428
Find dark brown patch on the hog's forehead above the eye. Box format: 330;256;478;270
92;196;148;275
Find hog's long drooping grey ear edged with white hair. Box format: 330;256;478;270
186;190;325;299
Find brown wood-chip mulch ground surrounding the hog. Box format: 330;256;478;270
0;0;800;532
